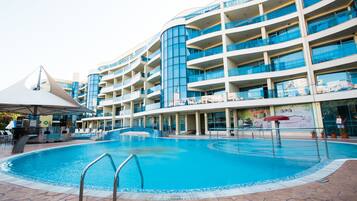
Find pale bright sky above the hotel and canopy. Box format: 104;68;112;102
0;0;212;90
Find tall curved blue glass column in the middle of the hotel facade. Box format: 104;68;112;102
161;25;187;107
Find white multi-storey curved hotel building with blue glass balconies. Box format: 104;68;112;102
82;0;357;135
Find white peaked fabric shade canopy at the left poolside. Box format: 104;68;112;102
0;66;92;115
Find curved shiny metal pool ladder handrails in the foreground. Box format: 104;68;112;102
79;153;144;201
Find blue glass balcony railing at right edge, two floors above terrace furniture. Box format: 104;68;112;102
308;9;357;34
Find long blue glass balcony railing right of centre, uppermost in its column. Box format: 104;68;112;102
226;4;296;29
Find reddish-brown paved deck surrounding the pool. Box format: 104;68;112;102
0;140;357;201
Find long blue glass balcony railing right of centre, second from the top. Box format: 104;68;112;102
227;29;301;51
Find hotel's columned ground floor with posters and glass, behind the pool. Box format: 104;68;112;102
80;98;357;137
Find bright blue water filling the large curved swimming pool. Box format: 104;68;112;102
1;137;357;192
